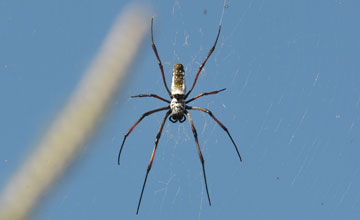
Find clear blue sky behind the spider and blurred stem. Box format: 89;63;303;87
0;0;360;219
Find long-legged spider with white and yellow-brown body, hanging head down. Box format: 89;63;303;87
118;18;242;214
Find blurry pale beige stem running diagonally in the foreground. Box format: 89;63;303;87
0;6;150;220
